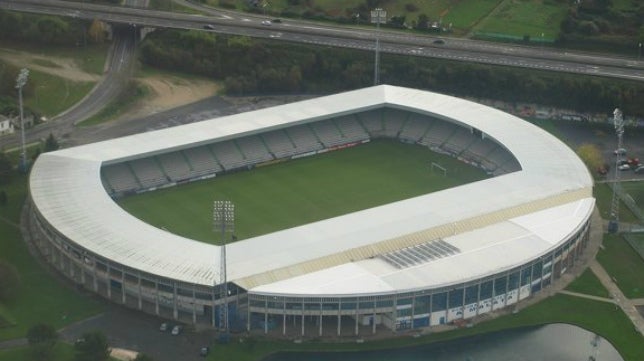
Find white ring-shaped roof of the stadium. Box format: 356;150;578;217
30;85;594;296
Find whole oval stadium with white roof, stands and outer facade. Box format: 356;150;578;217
28;85;595;338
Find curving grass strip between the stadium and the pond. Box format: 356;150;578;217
208;295;644;361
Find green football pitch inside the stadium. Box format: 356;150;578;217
118;140;488;244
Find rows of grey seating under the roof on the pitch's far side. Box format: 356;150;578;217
102;108;521;195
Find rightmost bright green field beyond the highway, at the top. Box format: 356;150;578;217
477;0;568;41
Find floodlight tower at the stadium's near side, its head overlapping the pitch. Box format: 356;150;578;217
212;201;235;334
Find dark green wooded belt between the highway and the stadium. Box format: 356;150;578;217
141;29;644;116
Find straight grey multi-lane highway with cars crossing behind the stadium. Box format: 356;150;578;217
0;0;644;81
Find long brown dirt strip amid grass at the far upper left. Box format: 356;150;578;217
0;48;100;82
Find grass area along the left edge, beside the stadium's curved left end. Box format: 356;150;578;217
0;176;101;340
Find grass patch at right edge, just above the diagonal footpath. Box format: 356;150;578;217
597;234;644;298
